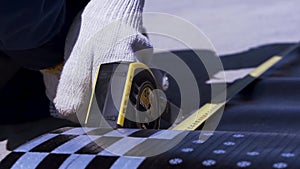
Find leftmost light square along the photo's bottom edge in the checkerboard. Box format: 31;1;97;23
12;152;49;169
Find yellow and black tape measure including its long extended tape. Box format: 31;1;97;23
85;43;300;130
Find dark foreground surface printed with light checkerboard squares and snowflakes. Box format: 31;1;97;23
0;127;300;169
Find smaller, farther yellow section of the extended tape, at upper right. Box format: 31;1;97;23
250;56;282;78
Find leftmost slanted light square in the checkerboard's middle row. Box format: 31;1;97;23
14;134;58;152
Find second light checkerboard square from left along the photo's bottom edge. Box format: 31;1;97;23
59;154;96;169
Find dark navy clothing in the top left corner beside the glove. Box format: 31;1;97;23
0;0;89;70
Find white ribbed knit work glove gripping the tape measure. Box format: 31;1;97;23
54;0;151;121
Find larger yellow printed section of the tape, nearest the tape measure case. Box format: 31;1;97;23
172;102;225;130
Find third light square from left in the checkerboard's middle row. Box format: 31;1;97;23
102;137;146;156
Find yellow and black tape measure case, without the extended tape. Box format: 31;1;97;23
85;62;172;129
